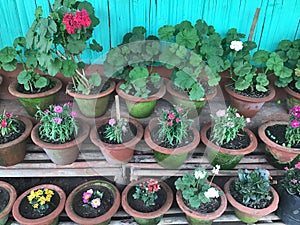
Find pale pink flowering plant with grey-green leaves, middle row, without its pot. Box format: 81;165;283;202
211;106;250;146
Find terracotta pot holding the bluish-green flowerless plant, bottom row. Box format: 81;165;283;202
224;177;279;223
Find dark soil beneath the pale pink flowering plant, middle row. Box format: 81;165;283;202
206;128;251;150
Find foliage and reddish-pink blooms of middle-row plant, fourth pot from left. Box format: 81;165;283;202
158;106;192;146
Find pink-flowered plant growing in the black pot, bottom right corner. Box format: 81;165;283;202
280;162;300;196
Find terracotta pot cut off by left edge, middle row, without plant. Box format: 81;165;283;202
0;116;32;166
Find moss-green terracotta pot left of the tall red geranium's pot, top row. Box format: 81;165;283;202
8;77;62;116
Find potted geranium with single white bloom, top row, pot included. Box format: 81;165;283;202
223;28;275;117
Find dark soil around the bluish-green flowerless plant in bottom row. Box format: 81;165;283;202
229;182;273;209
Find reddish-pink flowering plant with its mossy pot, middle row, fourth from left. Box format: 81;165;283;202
144;106;200;169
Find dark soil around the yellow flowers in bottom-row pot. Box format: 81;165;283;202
19;191;60;219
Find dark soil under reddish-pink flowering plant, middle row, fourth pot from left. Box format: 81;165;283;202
150;126;194;149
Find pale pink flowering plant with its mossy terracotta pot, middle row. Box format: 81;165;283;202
200;106;257;169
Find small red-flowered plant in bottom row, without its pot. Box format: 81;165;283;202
132;179;160;207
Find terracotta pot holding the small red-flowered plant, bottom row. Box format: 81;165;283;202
122;178;173;225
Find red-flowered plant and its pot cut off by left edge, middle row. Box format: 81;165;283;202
0;110;32;166
